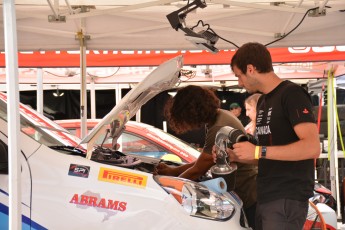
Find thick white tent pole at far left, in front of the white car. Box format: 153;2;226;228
3;0;22;229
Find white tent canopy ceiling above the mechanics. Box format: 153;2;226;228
0;0;345;51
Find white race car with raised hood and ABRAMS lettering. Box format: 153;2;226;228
0;56;249;230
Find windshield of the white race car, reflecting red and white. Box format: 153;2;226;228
0;94;80;147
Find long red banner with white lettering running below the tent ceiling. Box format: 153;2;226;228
0;46;345;68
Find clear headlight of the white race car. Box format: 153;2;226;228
154;176;235;220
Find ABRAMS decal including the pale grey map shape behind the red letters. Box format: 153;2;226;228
69;191;127;222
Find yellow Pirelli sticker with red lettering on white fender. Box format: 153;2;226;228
98;167;147;188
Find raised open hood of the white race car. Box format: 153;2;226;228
81;55;183;159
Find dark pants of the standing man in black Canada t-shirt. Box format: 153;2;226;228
255;199;308;230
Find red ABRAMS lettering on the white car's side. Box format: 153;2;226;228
70;194;127;212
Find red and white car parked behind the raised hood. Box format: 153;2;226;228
55;119;200;163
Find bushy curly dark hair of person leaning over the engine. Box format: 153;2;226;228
164;85;220;134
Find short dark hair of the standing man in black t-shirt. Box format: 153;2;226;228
230;42;273;74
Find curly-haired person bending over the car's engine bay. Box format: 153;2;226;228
156;85;257;227
